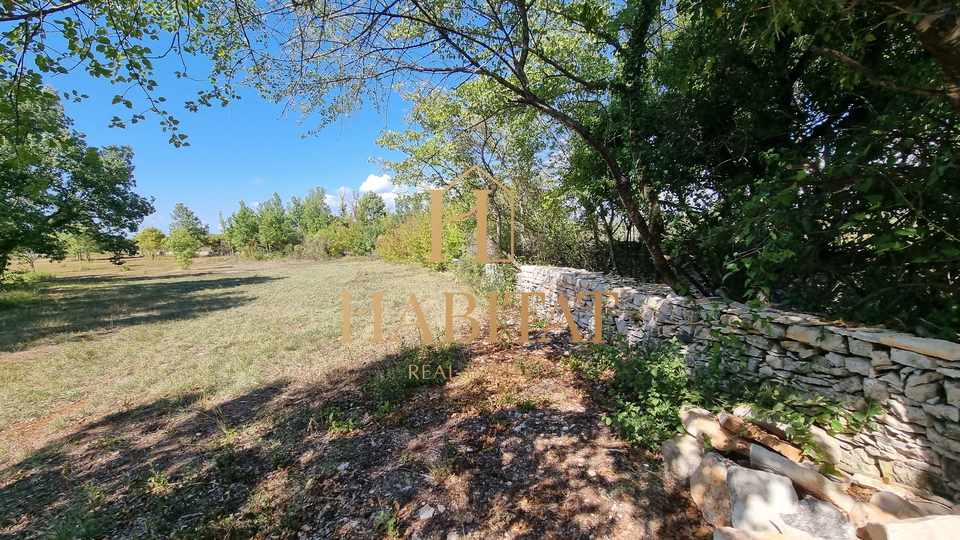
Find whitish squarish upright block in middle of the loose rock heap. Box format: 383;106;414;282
727;465;797;532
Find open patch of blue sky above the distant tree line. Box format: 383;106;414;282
46;63;409;232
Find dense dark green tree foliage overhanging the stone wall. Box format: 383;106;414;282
572;0;960;339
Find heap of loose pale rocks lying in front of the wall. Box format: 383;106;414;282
661;406;960;540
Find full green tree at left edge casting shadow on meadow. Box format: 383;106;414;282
0;89;153;273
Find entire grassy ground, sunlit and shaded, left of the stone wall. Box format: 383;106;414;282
0;258;696;540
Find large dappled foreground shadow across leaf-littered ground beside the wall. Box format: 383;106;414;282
0;340;689;540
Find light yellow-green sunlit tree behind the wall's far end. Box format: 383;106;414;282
377;80;593;266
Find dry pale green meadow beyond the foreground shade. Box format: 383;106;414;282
0;258;472;450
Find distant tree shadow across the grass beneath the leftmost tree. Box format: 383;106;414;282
0;273;283;351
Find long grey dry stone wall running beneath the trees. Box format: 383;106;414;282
516;266;960;502
